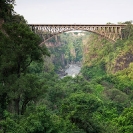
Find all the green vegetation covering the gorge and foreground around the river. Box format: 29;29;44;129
0;0;133;133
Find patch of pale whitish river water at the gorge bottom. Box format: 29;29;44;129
65;64;81;77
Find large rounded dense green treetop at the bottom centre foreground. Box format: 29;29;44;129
61;92;102;133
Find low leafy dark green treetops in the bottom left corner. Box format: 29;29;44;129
0;106;61;133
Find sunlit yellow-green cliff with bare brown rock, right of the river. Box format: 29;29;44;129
83;34;133;74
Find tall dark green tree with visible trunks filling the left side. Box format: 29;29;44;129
0;1;49;117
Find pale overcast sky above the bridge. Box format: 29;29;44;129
14;0;133;24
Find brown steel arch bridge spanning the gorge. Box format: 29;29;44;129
29;24;126;43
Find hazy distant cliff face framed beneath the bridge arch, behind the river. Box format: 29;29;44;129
45;32;84;70
